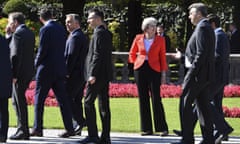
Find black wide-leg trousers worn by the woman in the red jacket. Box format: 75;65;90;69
134;61;168;132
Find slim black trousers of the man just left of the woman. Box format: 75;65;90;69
84;81;111;138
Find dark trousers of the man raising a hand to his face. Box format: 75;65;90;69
12;79;30;134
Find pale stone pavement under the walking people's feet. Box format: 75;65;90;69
7;128;240;144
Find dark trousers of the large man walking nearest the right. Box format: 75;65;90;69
180;77;214;144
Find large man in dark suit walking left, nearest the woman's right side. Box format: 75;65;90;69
174;3;215;144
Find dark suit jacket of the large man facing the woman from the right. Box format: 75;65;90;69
185;19;215;85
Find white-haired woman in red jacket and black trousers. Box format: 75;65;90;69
128;17;168;136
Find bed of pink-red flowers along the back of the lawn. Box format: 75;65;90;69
26;81;240;117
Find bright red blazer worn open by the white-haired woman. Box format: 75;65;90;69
128;34;168;72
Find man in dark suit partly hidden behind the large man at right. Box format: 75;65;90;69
174;14;233;144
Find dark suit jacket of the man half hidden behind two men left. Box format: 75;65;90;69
65;29;88;82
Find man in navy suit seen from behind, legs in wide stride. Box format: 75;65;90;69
31;9;74;137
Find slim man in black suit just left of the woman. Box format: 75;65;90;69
80;9;112;144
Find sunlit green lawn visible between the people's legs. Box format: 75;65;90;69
9;98;240;136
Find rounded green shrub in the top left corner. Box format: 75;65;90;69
3;0;28;15
